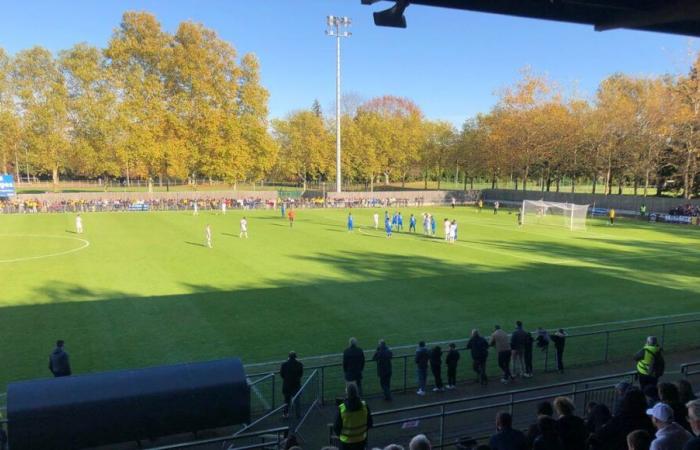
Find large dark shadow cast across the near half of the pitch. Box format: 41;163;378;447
0;241;700;388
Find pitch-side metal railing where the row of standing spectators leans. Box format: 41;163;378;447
246;318;700;404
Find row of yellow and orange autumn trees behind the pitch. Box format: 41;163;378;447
0;12;700;198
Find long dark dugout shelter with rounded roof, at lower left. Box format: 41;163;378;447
7;358;250;450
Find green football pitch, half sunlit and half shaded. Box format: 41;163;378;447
0;207;700;391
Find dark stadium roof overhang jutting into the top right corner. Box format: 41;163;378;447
361;0;700;36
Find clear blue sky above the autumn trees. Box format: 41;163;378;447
0;0;696;124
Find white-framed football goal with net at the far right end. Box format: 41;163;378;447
521;200;588;231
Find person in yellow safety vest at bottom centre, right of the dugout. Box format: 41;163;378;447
333;383;372;450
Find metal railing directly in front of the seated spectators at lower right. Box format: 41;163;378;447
328;372;635;448
